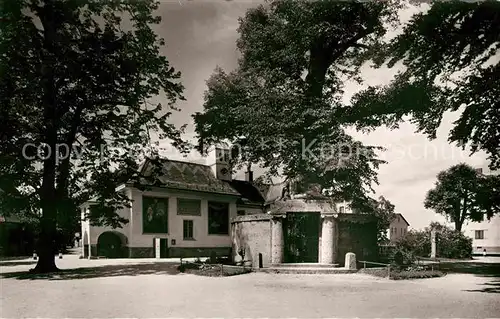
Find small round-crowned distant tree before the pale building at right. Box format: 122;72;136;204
424;164;500;231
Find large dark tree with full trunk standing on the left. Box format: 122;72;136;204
0;0;188;272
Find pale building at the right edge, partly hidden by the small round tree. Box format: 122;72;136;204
463;168;500;256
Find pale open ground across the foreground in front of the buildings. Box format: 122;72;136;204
0;256;500;318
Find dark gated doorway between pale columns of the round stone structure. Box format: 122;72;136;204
283;213;321;263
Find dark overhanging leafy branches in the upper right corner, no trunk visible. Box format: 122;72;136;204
348;1;500;169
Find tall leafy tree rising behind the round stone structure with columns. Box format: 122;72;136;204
194;0;397;209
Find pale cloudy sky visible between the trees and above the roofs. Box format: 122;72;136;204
148;0;488;229
